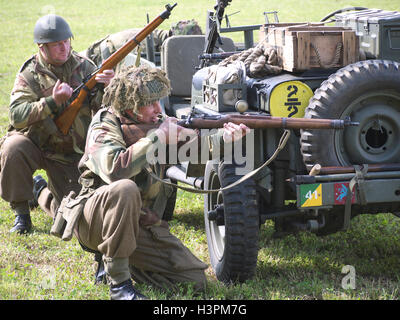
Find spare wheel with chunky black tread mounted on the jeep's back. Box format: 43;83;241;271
301;60;400;170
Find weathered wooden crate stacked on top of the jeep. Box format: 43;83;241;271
264;24;359;71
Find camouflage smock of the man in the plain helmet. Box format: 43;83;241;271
9;52;102;163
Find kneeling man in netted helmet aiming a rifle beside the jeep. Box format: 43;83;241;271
52;65;248;299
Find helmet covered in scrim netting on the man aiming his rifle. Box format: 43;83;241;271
103;65;171;116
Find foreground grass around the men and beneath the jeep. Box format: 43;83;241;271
0;188;400;300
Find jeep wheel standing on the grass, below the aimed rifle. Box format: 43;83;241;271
204;161;259;283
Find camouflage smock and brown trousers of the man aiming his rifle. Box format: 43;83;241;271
53;109;207;289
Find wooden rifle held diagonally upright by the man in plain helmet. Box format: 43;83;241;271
55;3;177;135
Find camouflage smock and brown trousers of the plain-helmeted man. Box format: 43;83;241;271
0;52;102;218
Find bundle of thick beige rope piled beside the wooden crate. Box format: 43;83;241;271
219;41;282;78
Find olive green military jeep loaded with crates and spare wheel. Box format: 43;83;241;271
140;1;400;283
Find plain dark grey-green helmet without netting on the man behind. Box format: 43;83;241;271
33;14;73;44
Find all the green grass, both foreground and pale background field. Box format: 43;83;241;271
0;0;400;300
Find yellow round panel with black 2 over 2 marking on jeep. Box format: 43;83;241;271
269;81;314;118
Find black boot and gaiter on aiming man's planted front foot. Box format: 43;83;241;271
103;256;146;300
